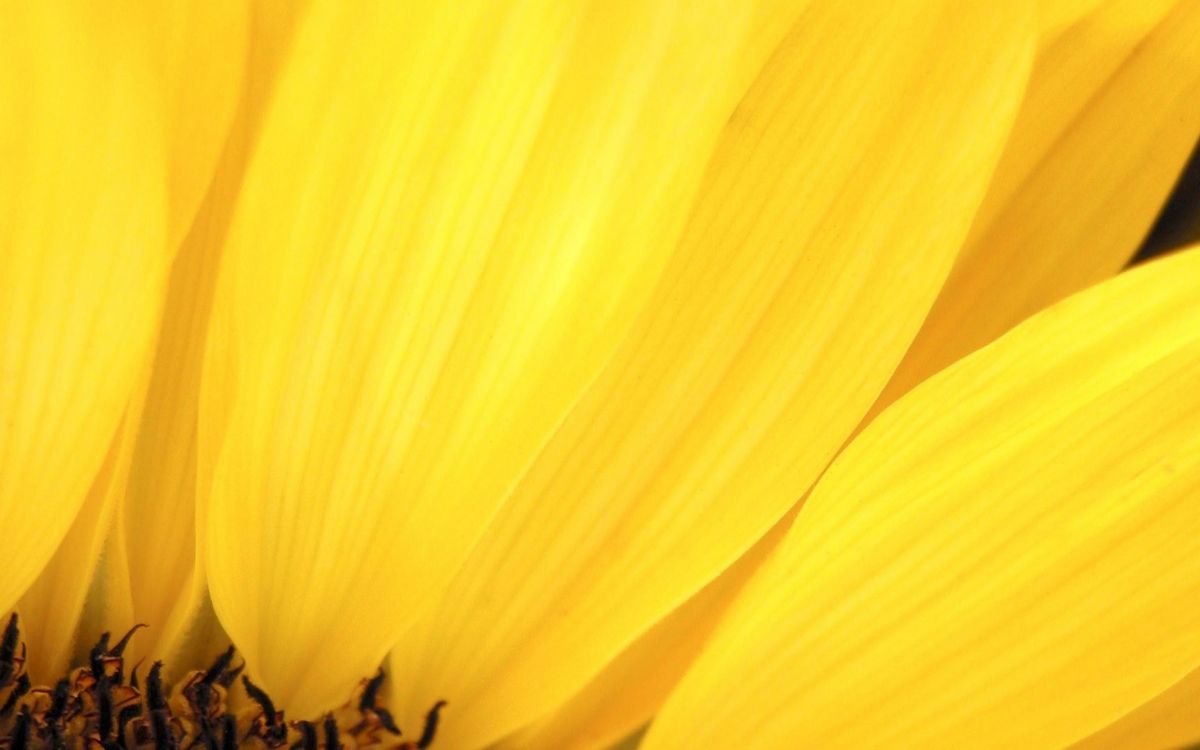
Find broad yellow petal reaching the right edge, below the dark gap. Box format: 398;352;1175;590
647;252;1200;748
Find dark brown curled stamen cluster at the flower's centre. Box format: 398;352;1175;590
0;614;445;750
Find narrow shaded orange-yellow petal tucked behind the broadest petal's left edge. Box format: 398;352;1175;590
107;1;312;668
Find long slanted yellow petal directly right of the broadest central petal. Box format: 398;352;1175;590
392;0;1031;746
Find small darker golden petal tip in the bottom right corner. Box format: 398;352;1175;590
1070;668;1200;750
